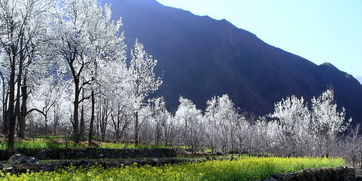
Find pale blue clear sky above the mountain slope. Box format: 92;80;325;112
157;0;362;79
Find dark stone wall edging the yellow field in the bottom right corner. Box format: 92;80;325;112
264;167;356;181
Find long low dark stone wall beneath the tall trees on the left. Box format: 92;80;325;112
0;148;176;160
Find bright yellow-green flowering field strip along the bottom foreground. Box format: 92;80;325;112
0;157;346;181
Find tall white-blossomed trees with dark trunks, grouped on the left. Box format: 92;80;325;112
0;0;162;152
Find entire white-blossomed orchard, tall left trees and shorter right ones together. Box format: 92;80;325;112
0;0;361;163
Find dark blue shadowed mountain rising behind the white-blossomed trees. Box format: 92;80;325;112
99;0;362;123
